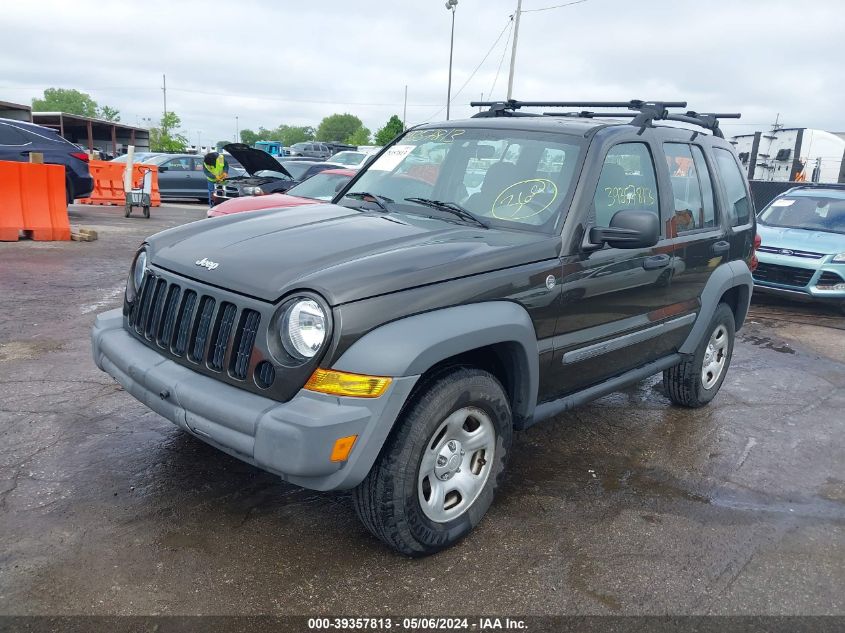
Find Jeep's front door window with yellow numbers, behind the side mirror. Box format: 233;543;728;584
593;143;660;226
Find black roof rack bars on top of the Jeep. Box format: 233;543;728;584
470;99;741;138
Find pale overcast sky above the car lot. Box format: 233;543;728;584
0;0;845;144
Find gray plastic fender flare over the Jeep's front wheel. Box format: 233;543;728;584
333;301;540;419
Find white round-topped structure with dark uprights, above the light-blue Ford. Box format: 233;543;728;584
731;128;845;183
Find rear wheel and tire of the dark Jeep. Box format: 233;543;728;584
663;303;736;408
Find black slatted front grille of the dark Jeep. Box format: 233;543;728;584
128;273;261;381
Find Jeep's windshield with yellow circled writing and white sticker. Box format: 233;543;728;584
340;128;581;231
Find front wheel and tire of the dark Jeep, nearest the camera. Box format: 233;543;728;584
353;368;513;557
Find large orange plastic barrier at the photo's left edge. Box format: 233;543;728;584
0;161;70;242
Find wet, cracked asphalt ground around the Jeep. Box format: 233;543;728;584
0;204;845;615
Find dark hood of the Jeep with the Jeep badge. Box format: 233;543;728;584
149;204;561;305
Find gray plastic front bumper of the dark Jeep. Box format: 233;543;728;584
91;310;419;490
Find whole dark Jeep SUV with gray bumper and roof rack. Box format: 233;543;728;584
92;101;755;556
